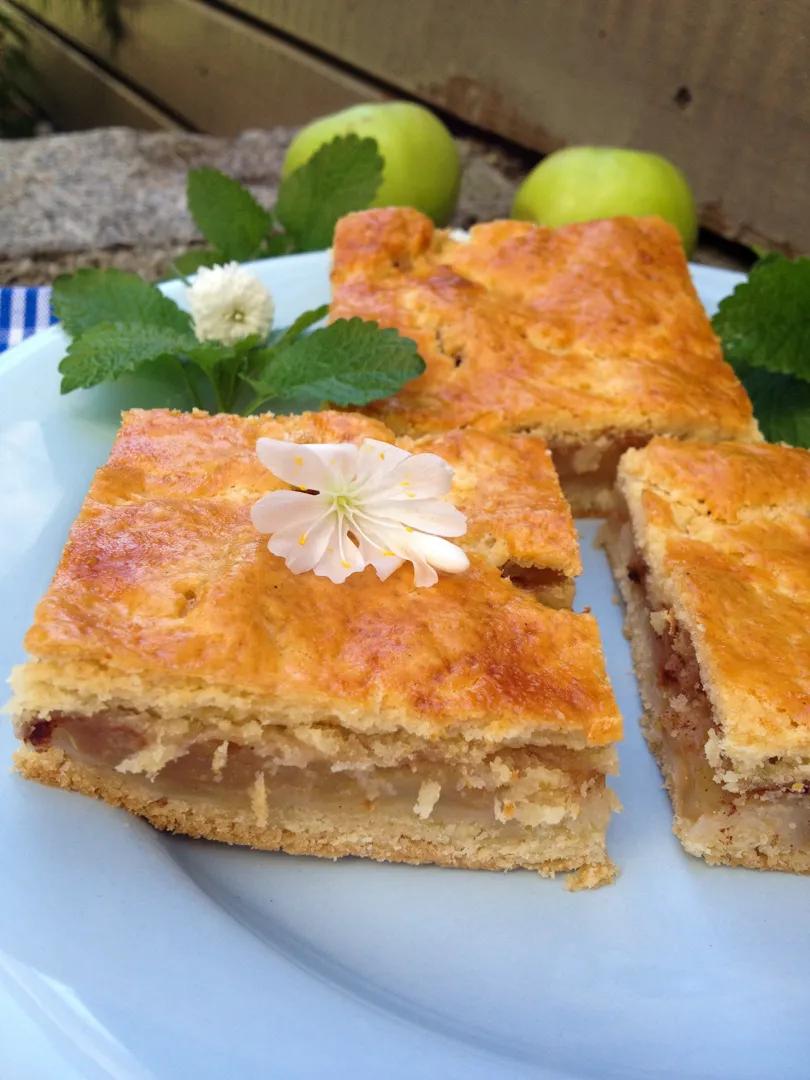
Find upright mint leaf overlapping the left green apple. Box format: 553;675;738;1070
275;135;384;252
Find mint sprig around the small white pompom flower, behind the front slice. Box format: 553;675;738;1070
53;270;424;416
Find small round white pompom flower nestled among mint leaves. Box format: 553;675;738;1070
186;262;273;345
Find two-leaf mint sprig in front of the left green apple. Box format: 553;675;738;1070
185;135;384;263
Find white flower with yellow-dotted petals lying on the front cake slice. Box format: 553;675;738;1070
251;438;470;585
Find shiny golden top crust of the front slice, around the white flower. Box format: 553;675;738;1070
26;410;621;745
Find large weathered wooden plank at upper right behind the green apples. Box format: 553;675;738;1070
239;0;810;251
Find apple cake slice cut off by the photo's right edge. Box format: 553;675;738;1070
603;438;810;873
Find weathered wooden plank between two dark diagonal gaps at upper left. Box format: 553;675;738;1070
12;0;380;135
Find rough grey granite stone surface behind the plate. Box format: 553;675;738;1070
0;127;525;284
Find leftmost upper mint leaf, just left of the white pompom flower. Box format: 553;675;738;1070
51;270;191;337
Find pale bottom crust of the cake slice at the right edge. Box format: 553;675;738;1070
599;521;810;874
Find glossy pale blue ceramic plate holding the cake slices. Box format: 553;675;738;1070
0;254;810;1080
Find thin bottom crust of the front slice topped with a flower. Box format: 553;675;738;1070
14;747;616;889
